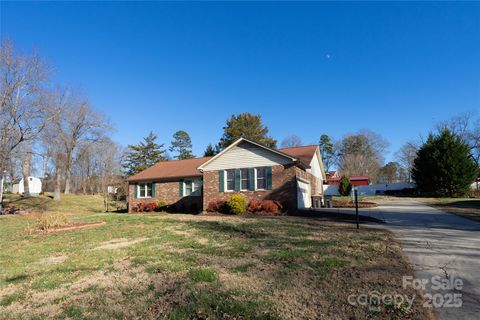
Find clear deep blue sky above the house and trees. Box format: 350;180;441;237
0;1;480;158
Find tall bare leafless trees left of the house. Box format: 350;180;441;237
0;40;121;200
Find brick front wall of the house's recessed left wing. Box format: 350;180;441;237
128;180;202;212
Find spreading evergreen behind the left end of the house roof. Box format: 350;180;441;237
122;132;167;176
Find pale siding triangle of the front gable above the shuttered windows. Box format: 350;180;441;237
203;142;293;171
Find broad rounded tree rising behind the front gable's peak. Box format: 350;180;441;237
218;113;277;150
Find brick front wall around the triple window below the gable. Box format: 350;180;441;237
203;165;297;211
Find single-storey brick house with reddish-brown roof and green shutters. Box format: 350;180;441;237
128;138;326;212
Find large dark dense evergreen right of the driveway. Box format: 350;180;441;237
412;129;478;197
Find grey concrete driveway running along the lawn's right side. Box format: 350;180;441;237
368;200;480;319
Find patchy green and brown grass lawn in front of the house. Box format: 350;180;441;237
0;195;431;319
